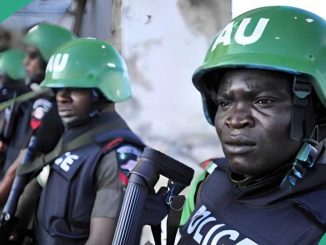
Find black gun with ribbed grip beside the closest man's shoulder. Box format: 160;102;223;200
112;147;194;245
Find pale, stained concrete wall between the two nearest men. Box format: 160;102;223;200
113;0;231;169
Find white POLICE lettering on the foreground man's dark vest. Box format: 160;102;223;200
187;205;258;245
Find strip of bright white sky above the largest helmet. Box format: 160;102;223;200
232;0;326;19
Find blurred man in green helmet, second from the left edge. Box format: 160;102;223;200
0;23;76;178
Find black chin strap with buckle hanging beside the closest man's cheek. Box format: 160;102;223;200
280;77;325;189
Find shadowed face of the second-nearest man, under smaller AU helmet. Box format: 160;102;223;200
56;88;92;125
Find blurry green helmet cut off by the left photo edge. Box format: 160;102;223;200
0;49;25;80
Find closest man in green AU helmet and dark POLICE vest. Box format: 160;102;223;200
178;6;326;245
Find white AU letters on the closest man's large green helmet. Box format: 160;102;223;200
211;18;269;51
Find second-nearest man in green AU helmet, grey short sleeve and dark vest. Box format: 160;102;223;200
13;38;144;244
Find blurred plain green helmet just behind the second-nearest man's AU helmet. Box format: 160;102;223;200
23;23;76;62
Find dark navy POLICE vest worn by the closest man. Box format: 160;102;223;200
178;163;326;245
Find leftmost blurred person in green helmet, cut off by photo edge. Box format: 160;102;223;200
0;49;29;181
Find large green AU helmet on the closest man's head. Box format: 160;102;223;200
193;6;326;124
